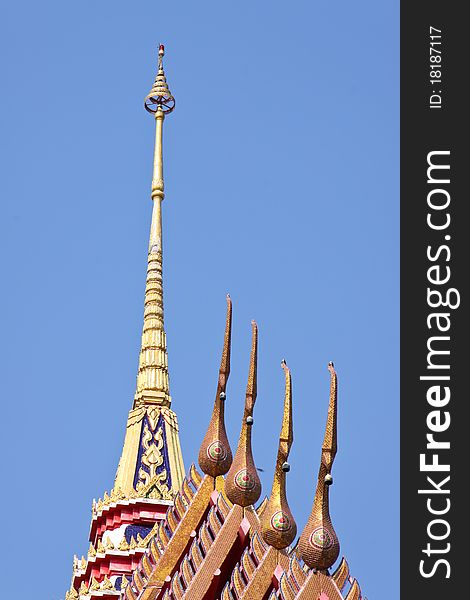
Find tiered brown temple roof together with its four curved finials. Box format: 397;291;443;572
120;302;362;600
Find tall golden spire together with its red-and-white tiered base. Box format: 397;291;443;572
69;46;184;597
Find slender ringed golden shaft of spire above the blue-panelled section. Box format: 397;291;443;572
134;46;175;407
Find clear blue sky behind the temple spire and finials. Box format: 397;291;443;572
0;0;399;600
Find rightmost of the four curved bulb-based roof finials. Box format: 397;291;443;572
299;362;339;570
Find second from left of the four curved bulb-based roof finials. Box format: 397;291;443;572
225;321;261;506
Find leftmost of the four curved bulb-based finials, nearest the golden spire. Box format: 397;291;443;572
199;295;232;477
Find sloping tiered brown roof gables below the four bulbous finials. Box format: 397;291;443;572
124;466;362;600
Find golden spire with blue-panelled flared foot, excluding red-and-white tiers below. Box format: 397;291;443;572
115;46;184;500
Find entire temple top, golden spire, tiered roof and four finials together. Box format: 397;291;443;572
66;46;362;600
